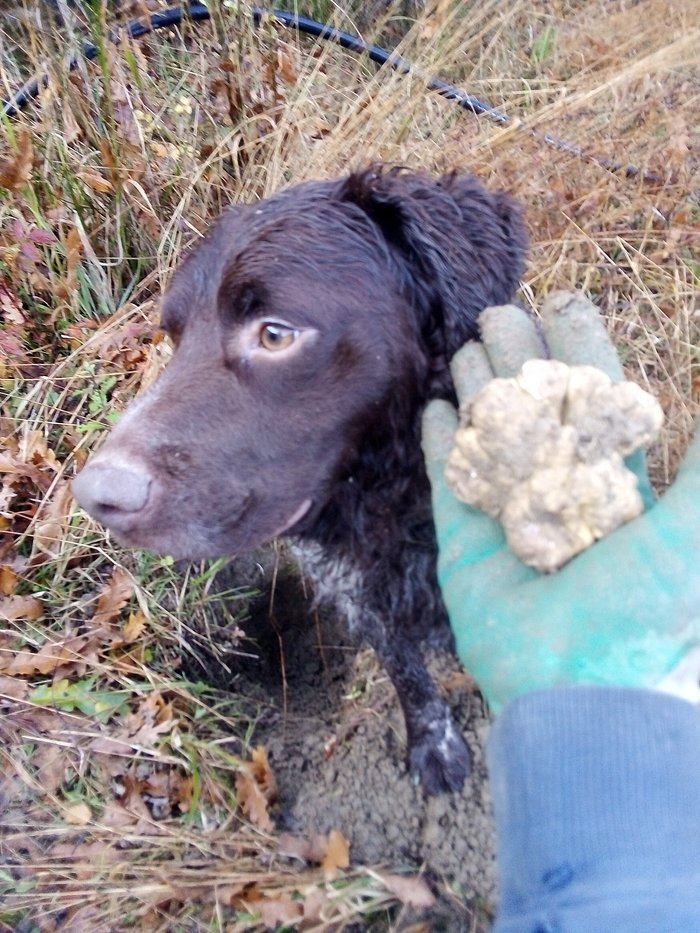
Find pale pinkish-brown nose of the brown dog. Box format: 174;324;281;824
73;461;153;529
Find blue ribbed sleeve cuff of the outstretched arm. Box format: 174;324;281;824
488;687;700;933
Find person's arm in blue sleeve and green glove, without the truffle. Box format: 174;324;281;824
424;303;700;933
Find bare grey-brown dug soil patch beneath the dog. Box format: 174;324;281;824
191;552;495;916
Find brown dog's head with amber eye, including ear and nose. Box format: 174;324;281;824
73;169;524;558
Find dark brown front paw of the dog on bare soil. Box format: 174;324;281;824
409;717;471;796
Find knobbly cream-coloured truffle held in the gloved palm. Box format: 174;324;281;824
445;360;663;571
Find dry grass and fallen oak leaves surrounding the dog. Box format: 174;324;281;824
0;0;700;931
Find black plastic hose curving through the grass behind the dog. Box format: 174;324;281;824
2;0;661;184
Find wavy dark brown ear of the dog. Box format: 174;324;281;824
340;168;526;374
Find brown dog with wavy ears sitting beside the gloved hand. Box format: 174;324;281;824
73;166;526;794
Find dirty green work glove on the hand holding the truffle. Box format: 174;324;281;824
423;298;700;712
